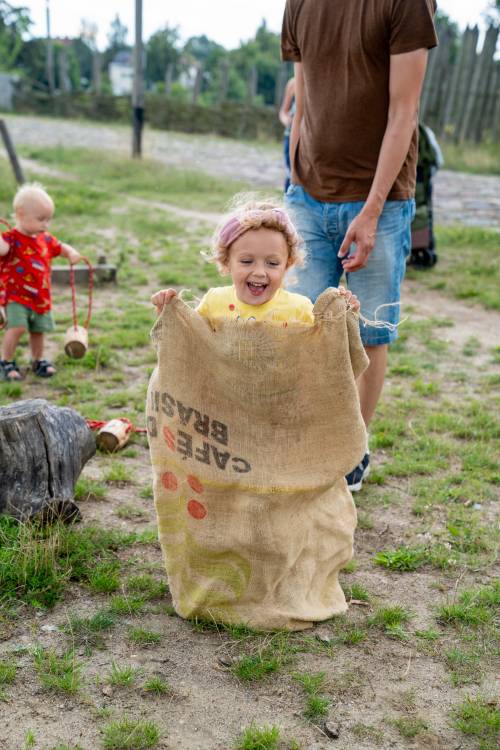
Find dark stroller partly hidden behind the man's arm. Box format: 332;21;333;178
409;124;444;268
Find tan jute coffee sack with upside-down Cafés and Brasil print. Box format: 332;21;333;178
147;289;367;630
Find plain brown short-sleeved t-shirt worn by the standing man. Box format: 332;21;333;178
281;0;437;203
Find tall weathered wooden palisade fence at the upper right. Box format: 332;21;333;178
420;26;500;143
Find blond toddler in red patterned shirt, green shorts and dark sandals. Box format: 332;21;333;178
0;183;81;380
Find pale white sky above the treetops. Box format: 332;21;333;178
21;0;488;49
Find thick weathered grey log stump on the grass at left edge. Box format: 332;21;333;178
0;399;96;520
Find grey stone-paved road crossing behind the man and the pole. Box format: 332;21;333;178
5;116;500;229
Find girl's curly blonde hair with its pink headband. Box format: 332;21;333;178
204;193;305;274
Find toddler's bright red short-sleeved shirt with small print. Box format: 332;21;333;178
0;229;62;314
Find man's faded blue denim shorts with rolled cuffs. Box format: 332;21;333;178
285;184;415;346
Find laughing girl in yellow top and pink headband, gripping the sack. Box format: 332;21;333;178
151;195;359;325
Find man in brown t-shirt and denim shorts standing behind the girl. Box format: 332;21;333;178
281;0;437;490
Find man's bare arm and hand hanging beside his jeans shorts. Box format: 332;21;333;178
340;49;427;273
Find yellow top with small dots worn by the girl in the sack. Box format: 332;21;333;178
196;286;314;324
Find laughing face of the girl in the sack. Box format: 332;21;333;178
227;227;288;305
